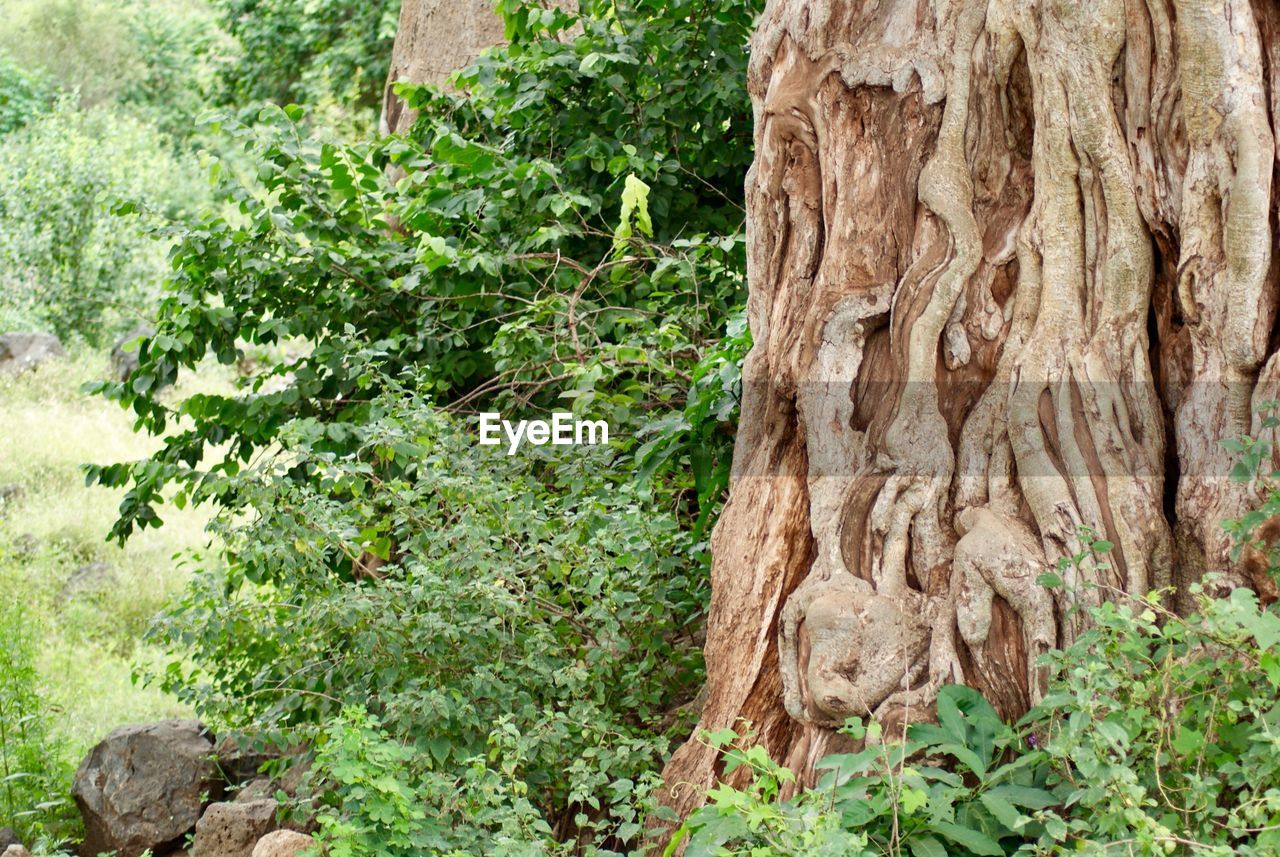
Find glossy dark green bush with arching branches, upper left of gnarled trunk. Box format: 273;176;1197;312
91;0;751;547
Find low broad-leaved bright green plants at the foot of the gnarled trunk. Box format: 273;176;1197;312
667;686;1064;857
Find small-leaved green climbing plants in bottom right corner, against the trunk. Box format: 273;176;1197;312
1018;405;1280;856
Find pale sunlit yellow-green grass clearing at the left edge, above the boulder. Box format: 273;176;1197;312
0;352;229;767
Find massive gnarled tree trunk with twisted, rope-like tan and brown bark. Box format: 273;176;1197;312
666;0;1280;812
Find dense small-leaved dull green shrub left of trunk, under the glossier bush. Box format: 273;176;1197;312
147;395;705;854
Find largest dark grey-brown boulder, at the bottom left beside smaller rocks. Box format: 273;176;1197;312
72;720;216;857
